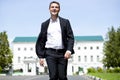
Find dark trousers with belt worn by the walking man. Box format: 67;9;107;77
46;49;68;80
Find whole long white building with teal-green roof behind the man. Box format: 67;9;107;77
12;36;104;75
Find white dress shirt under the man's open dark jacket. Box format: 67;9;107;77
45;18;64;49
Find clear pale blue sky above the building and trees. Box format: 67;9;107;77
0;0;120;40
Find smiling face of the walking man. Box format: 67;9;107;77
49;3;60;16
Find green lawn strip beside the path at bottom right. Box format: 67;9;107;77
89;73;120;80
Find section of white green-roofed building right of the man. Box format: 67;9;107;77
72;36;104;73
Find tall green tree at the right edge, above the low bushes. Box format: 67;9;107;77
103;27;120;68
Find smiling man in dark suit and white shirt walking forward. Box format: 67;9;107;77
36;1;74;80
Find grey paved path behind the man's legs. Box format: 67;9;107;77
0;75;91;80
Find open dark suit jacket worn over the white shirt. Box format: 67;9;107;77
36;17;74;58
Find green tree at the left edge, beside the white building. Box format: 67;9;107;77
0;32;13;69
